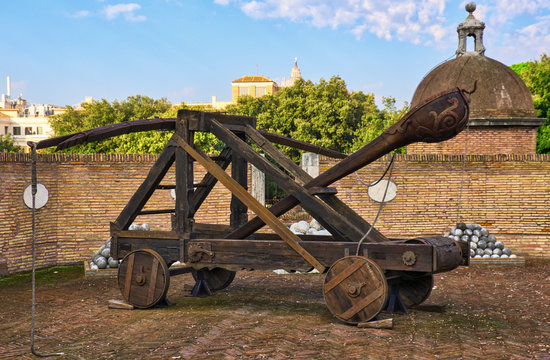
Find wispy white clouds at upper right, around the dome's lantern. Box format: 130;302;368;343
220;0;550;62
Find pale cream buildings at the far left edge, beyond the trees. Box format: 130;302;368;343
0;76;65;151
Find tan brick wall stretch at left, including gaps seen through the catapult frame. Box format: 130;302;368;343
0;153;235;273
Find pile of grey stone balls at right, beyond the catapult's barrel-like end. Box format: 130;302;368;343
445;222;517;259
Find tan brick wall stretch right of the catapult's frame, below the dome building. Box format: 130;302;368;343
320;154;550;258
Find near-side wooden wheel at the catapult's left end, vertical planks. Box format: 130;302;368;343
118;249;170;309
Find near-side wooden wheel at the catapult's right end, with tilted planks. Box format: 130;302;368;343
323;256;388;324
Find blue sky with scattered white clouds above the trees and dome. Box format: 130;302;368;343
0;0;550;106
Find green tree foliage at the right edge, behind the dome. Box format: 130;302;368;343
511;54;550;153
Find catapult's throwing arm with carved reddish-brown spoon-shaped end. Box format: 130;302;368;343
226;88;469;241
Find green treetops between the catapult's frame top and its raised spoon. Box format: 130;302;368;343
226;76;401;160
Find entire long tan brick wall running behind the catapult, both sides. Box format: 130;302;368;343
0;153;550;273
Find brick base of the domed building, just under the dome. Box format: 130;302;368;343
407;126;537;155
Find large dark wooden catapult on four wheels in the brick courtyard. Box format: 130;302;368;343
35;88;471;324
